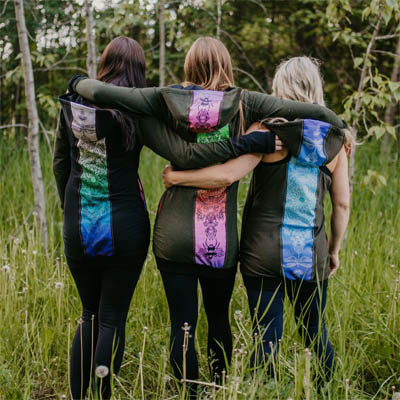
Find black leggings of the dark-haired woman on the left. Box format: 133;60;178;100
68;260;143;400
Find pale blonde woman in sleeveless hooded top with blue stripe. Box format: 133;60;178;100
163;57;352;380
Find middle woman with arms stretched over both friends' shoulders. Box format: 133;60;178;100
72;42;342;396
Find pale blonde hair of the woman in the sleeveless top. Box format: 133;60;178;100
272;56;354;152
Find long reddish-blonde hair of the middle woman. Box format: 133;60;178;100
182;36;234;90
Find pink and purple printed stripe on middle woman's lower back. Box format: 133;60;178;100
194;188;227;268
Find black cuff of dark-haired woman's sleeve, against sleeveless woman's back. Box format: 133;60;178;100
232;131;275;155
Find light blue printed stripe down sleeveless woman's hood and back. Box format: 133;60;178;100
281;120;330;281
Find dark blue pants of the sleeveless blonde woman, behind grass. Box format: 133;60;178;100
243;276;334;384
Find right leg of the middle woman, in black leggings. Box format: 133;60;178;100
200;274;236;382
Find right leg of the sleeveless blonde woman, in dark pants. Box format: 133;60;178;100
288;280;334;383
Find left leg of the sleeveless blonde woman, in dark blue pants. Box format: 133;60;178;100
243;276;285;375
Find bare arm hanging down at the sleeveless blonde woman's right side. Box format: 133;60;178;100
329;149;350;275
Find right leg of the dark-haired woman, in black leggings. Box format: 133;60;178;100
94;261;143;399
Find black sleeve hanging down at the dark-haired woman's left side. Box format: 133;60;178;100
53;111;71;208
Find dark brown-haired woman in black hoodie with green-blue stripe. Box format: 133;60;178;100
53;37;275;399
